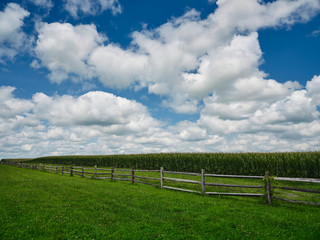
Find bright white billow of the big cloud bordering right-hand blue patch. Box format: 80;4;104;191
184;33;262;98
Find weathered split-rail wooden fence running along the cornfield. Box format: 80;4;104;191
0;161;320;206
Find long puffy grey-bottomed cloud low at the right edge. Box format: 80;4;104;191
197;74;320;139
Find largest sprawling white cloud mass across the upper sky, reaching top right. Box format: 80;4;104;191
34;0;320;113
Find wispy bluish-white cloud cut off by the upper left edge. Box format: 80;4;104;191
0;3;30;62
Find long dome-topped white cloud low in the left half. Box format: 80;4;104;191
33;92;158;134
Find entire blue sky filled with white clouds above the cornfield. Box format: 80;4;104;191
0;0;320;158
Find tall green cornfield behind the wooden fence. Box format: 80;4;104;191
15;152;320;178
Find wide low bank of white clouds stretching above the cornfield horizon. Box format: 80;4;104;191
0;72;320;157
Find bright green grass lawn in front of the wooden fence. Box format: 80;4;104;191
0;165;320;240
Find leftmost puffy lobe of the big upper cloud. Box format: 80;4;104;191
35;23;105;83
